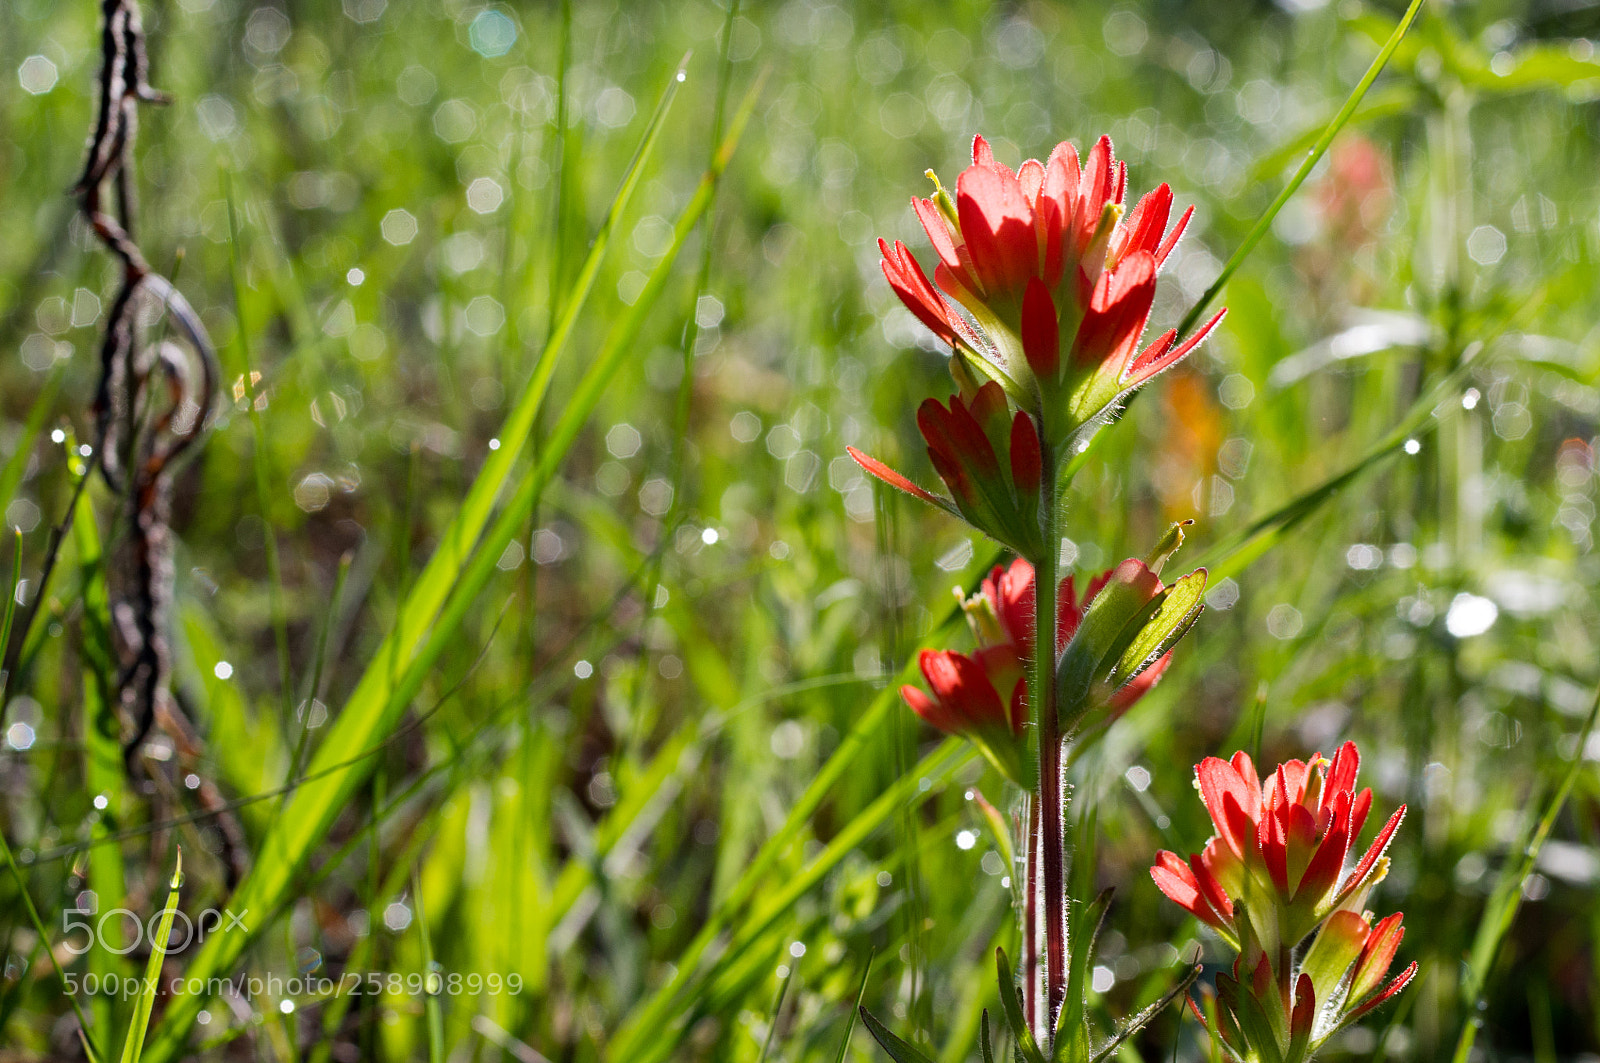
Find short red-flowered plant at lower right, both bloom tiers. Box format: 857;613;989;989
1150;741;1416;1063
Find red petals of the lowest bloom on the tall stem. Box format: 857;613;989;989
901;559;1171;780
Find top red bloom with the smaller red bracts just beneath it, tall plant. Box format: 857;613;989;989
851;136;1222;541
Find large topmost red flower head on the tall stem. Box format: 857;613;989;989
878;136;1222;447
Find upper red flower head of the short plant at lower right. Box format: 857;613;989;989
1150;741;1405;949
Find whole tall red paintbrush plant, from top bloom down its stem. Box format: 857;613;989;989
850;138;1221;1063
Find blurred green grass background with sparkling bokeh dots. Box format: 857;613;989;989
0;0;1600;1063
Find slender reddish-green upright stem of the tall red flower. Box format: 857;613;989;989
1027;442;1067;1033
